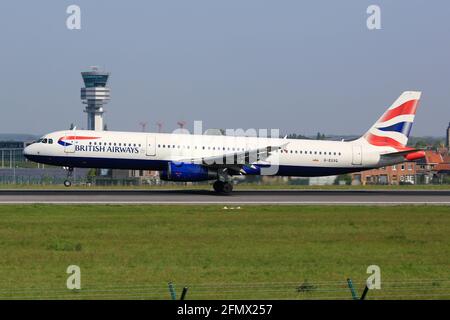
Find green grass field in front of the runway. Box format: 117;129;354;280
0;205;450;299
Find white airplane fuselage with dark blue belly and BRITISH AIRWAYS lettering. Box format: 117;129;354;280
24;130;404;176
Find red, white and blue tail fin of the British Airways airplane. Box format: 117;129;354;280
362;91;421;150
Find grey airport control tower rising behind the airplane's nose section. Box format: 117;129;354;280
81;67;110;131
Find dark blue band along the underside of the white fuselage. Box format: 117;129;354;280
25;155;370;177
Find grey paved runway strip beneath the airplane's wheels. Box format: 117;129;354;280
0;189;450;205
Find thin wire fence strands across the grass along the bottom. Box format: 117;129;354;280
0;279;450;300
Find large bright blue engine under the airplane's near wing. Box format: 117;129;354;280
159;162;217;182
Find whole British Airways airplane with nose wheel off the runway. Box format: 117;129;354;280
24;91;425;194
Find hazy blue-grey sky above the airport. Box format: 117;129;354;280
0;0;450;136
